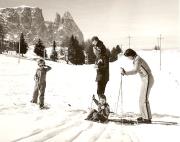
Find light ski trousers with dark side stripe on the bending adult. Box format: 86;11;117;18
139;75;154;119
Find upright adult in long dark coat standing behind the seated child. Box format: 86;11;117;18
92;36;109;97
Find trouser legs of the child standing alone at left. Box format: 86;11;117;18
32;83;46;106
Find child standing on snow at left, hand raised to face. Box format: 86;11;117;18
31;59;51;109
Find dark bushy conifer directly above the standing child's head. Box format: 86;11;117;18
34;39;47;58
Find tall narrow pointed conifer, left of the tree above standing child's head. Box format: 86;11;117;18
16;33;28;56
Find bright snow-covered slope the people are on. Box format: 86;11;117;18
0;51;180;142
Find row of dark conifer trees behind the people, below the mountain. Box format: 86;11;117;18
3;33;122;65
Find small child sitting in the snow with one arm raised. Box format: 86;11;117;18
85;95;110;123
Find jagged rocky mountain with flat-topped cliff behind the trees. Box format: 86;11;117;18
0;6;84;45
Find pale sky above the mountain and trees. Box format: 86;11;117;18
0;0;180;48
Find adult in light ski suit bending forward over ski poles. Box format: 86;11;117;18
121;49;154;123
